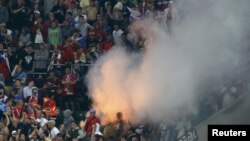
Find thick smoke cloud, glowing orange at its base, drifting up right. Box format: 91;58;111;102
88;0;250;121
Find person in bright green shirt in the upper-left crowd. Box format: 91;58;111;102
48;21;62;46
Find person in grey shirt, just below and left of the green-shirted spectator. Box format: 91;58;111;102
34;44;49;72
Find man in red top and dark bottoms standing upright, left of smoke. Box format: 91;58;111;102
62;67;76;110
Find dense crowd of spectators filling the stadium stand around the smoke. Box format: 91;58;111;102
0;0;246;141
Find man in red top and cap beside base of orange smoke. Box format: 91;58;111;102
84;109;100;137
